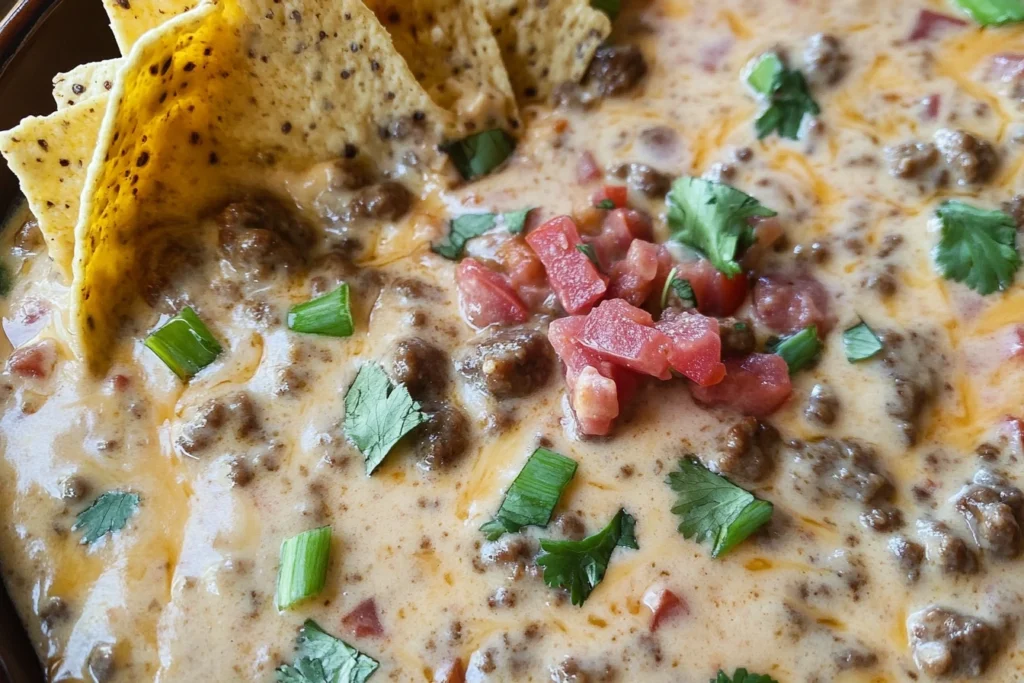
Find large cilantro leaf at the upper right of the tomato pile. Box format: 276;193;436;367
667;176;776;276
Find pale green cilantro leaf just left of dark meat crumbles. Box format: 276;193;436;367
345;362;427;474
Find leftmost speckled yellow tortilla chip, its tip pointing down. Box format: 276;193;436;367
0;95;106;281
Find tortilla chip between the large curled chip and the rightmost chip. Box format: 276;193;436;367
366;0;519;134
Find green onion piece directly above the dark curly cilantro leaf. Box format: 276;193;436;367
480;449;577;541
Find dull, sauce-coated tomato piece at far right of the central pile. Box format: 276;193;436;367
754;274;836;336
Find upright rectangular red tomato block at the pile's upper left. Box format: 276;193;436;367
526;216;608;314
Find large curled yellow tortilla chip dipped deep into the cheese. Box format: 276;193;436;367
72;0;459;373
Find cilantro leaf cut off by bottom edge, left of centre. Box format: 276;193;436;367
276;620;380;683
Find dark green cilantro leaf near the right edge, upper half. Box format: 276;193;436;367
934;200;1021;294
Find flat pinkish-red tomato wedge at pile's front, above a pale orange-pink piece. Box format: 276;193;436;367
580;299;672;380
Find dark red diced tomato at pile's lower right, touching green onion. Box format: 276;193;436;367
690;353;793;418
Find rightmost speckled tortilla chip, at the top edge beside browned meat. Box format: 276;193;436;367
481;0;611;100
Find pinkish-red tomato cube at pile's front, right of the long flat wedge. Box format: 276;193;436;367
654;312;725;386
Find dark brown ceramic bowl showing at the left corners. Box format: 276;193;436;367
0;0;118;683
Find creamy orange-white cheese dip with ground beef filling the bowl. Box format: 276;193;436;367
0;0;1024;683
